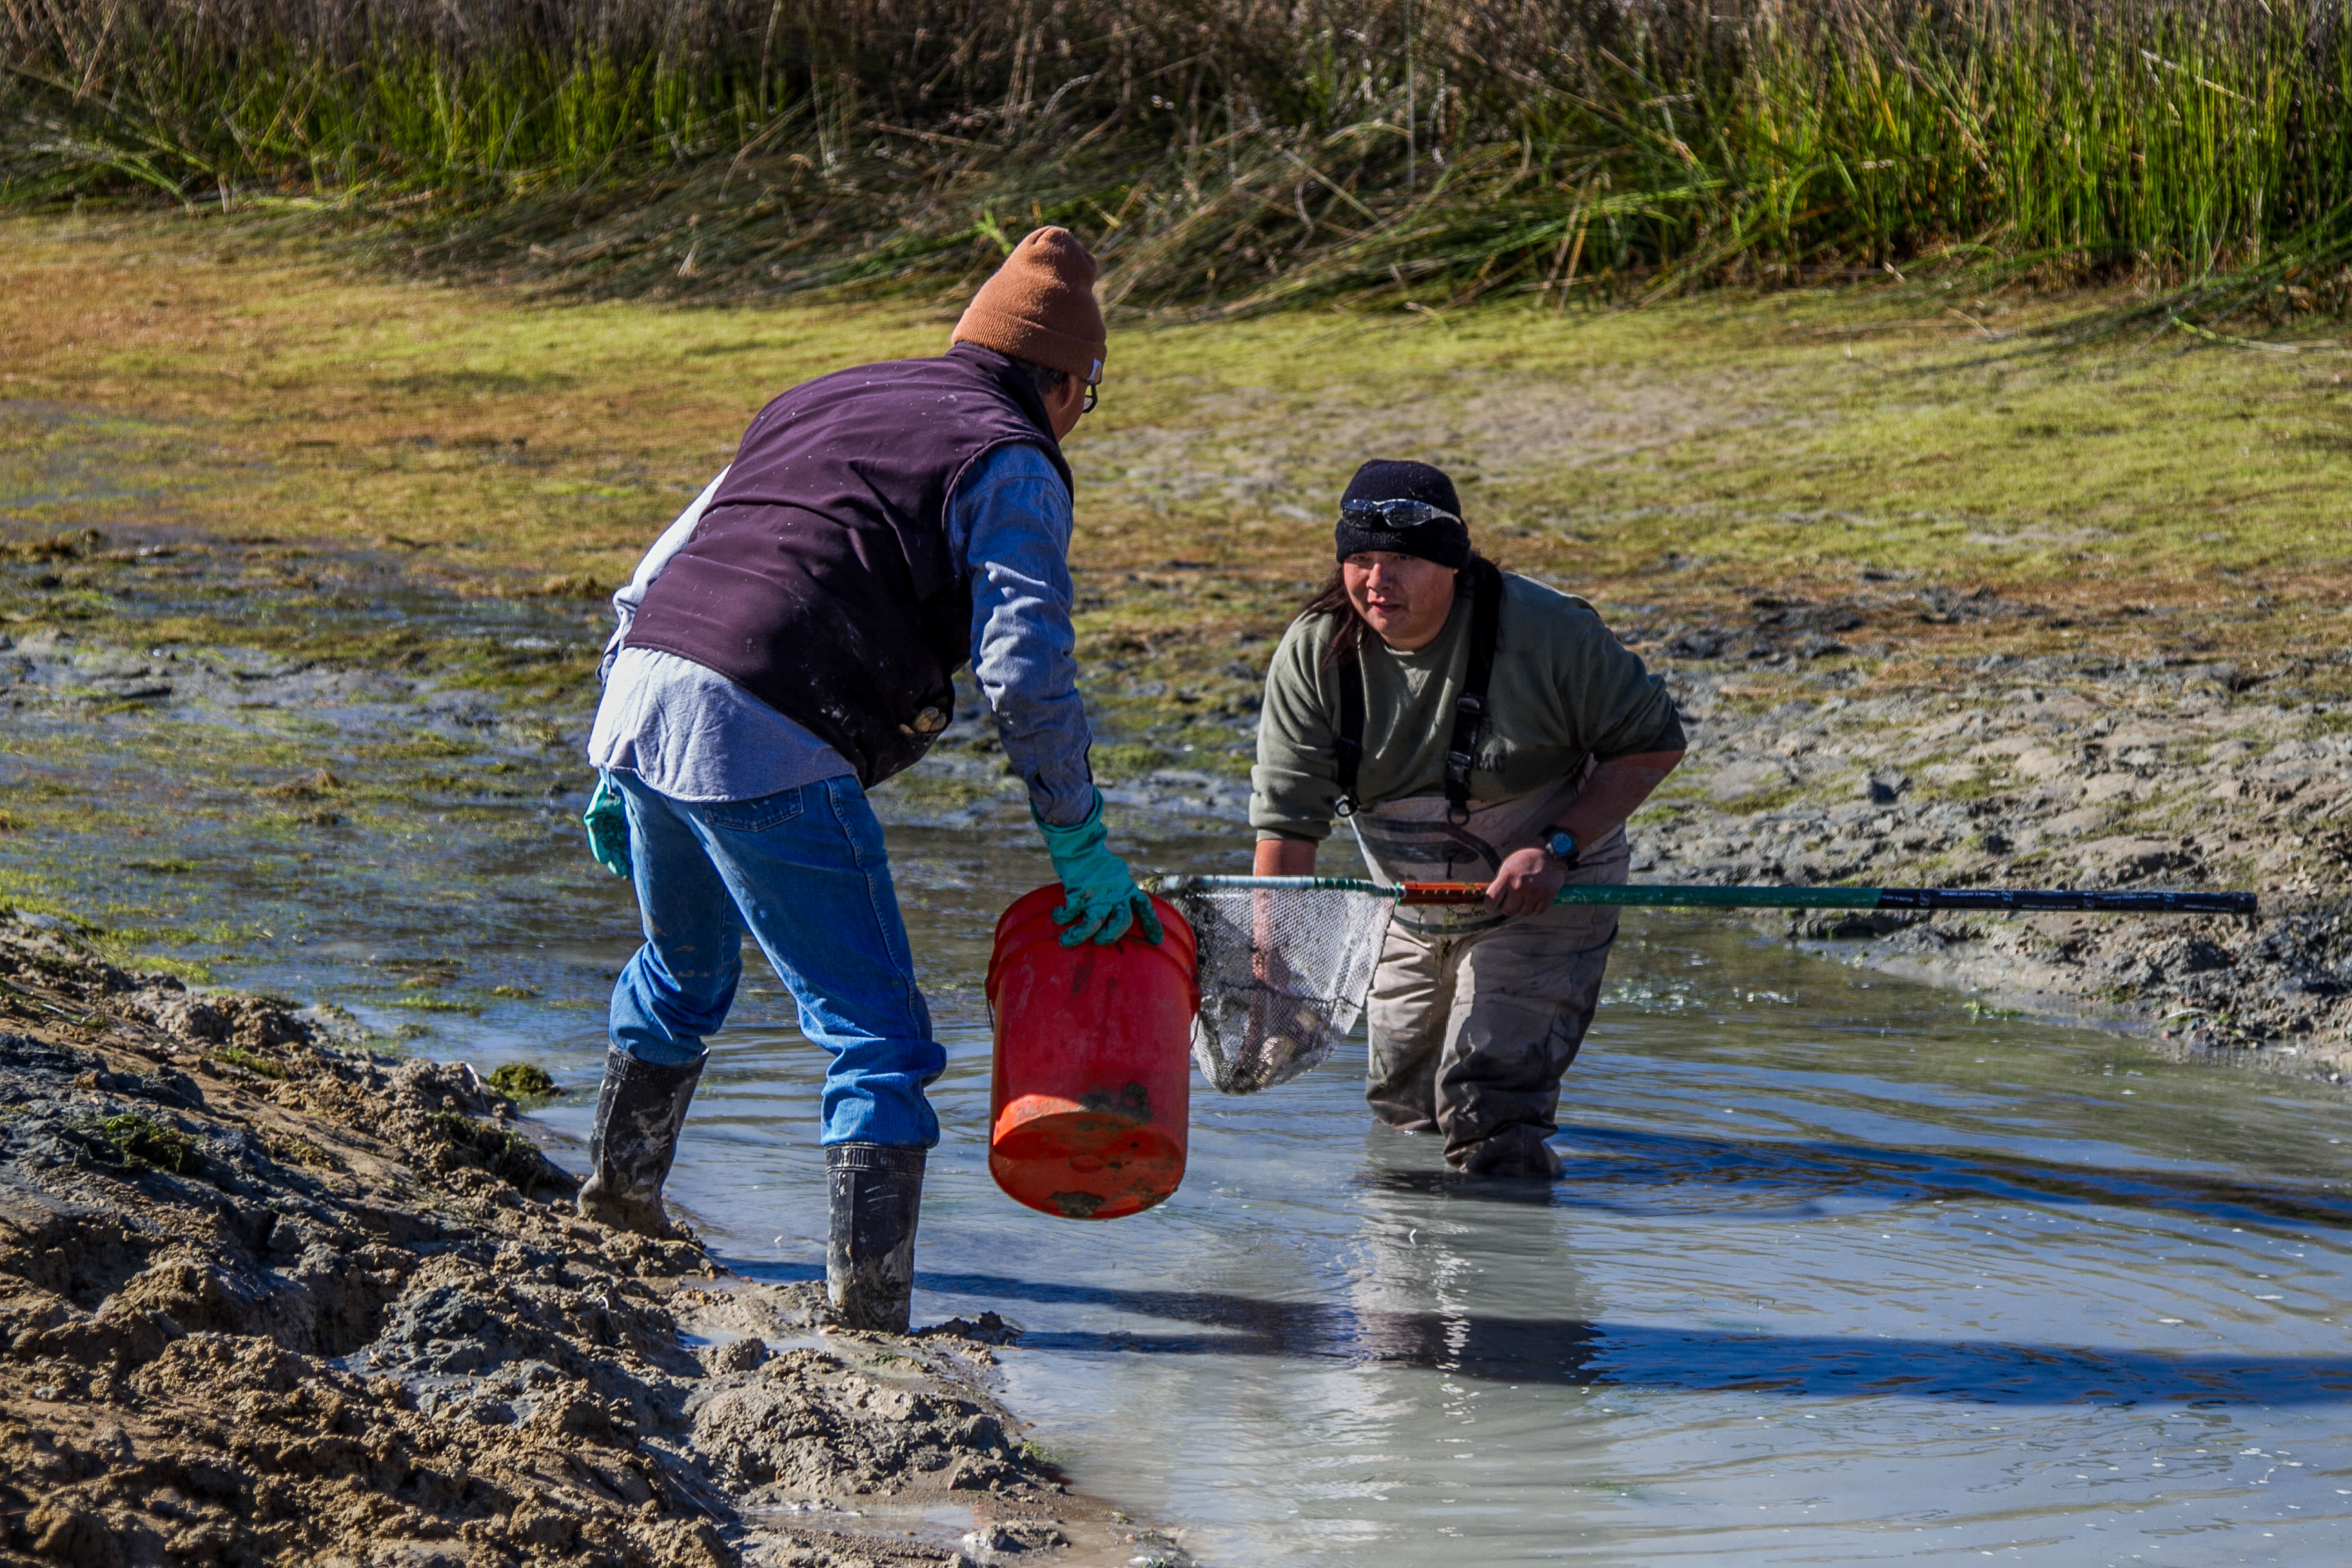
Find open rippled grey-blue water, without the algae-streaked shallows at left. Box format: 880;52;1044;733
496;832;2352;1568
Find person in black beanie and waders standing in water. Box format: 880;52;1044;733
1249;461;1684;1180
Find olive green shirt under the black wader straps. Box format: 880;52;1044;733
1249;571;1674;839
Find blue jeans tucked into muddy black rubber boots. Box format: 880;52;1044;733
612;774;948;1149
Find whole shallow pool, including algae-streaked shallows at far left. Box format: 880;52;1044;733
0;510;2352;1568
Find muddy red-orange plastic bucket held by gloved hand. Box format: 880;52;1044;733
988;884;1200;1220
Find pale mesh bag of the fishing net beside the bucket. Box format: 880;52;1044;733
1174;889;1395;1096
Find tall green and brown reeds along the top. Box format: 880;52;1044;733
13;0;2352;327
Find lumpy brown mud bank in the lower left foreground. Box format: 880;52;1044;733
0;917;1186;1568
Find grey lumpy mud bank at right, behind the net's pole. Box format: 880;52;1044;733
1635;648;2352;1077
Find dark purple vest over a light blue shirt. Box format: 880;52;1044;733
626;343;1070;788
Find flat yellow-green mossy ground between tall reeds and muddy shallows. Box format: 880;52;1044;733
0;218;2352;719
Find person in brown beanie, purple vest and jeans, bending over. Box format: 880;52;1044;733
578;228;1160;1333
